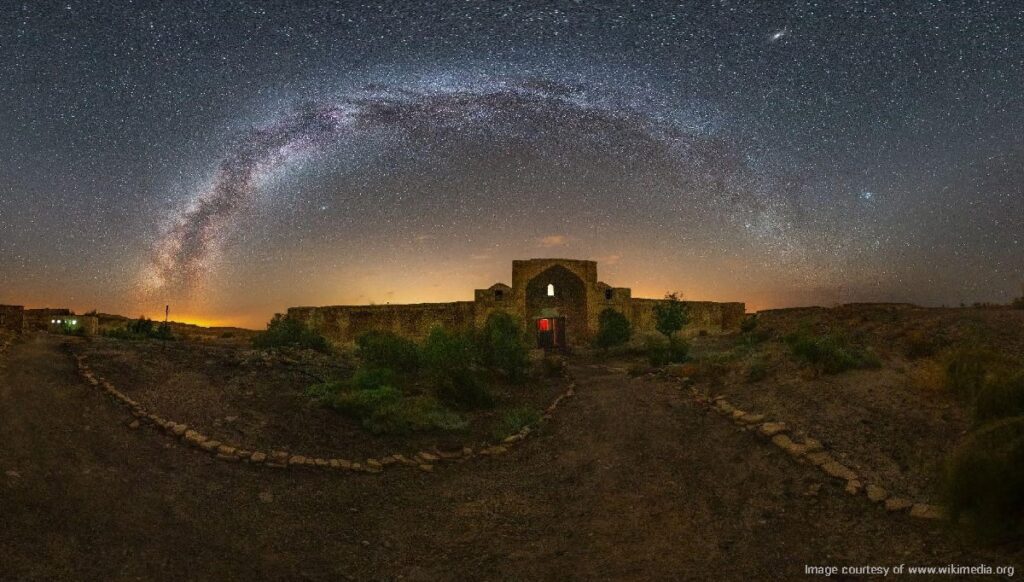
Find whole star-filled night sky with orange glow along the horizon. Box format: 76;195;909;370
0;0;1024;327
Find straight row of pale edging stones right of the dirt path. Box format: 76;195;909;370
647;366;948;519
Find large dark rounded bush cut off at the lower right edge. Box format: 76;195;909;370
945;416;1024;536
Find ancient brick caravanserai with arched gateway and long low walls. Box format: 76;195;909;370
288;258;744;346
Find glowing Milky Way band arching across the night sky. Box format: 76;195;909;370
142;80;766;292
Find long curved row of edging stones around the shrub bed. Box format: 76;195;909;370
71;349;575;473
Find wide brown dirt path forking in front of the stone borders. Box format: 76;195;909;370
0;335;1013;580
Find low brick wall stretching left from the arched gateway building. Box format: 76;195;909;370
288;301;476;343
